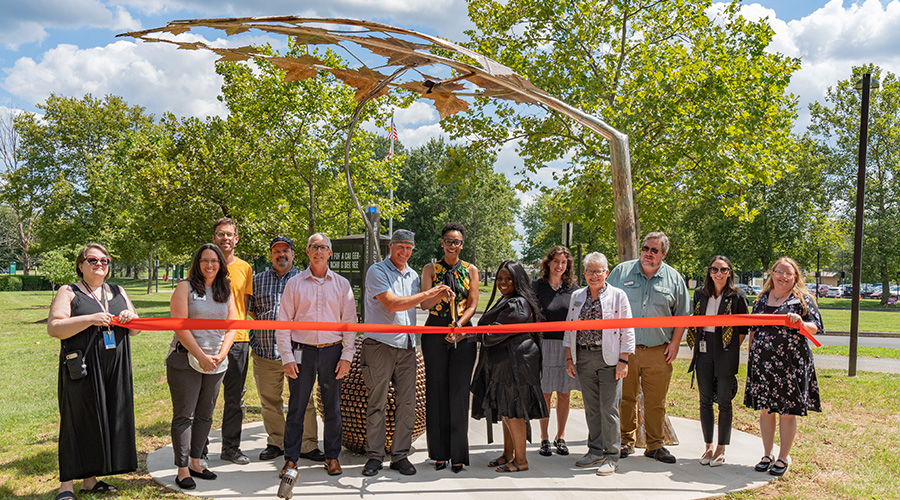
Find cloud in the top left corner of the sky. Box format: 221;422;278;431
0;0;140;50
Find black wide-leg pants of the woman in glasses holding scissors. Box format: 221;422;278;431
422;316;477;465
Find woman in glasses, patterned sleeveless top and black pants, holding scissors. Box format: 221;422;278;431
421;222;478;473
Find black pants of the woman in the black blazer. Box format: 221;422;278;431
694;353;737;446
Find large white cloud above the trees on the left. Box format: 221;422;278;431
0;41;225;117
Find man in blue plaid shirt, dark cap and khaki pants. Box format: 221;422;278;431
248;236;325;462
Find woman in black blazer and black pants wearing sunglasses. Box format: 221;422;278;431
688;255;748;467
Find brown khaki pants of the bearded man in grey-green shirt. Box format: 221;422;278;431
619;344;672;450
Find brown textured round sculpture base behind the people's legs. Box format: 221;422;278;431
316;337;425;455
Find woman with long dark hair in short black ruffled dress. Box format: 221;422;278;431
472;260;549;472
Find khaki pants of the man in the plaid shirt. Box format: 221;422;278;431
253;353;319;453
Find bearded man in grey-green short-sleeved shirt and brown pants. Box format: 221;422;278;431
606;232;691;464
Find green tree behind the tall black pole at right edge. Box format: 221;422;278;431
807;64;900;303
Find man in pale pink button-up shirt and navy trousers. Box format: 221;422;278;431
275;233;357;475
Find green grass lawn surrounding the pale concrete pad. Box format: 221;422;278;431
0;281;900;500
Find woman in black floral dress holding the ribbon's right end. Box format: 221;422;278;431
744;257;824;476
